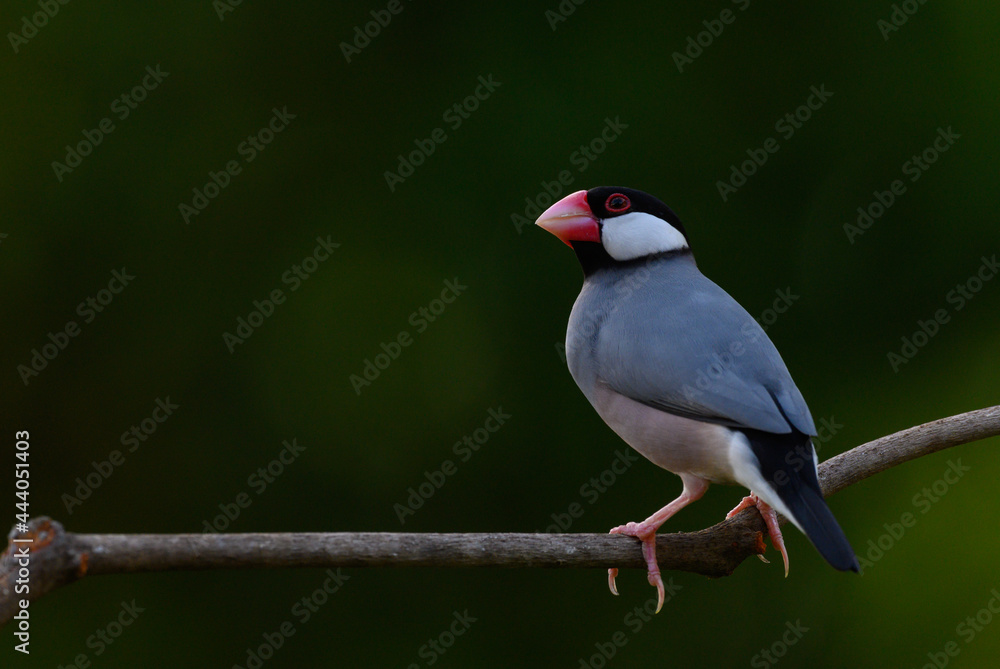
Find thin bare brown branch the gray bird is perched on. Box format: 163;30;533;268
0;406;1000;625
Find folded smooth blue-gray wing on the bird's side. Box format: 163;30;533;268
592;263;816;435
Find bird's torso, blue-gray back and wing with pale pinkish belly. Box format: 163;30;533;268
566;250;815;481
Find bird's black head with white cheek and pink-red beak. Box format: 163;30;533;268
536;186;690;274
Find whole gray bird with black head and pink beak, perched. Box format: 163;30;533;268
536;187;859;611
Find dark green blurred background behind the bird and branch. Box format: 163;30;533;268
0;0;1000;667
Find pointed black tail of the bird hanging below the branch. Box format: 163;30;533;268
744;430;861;572
